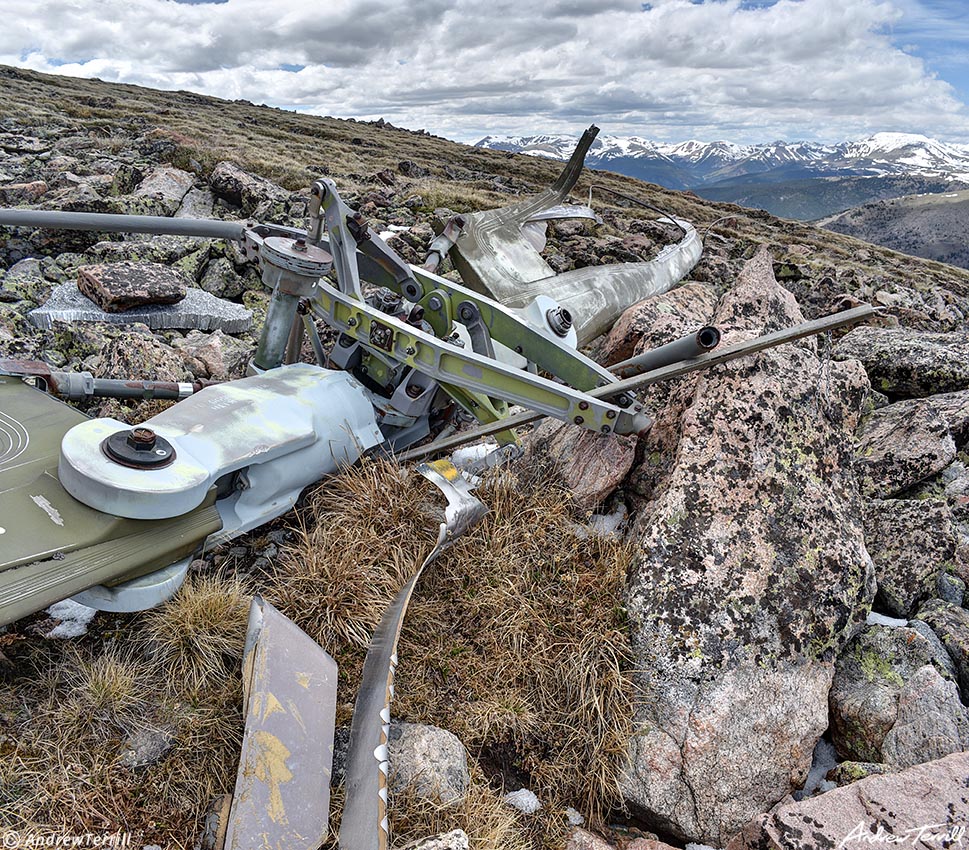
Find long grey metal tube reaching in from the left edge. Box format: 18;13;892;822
0;209;246;241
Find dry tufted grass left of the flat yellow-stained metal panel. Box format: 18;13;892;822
0;576;248;848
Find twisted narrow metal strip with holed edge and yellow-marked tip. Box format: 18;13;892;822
340;460;487;850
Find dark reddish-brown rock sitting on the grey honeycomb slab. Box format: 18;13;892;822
77;262;187;313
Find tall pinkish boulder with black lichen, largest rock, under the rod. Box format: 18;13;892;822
622;252;875;844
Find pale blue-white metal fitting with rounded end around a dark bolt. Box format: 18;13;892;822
58;363;383;528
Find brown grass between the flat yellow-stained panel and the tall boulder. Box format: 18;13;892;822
268;461;632;847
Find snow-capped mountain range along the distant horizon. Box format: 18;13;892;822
476;133;969;189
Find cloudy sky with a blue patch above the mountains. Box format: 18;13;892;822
0;0;969;142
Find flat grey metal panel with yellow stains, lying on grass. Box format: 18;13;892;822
224;596;337;850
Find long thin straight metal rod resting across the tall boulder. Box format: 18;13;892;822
395;304;878;463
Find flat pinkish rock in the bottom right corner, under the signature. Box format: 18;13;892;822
726;753;969;850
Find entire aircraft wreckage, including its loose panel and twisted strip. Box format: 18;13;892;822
0;127;875;850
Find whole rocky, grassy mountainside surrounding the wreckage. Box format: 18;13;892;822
0;69;969;850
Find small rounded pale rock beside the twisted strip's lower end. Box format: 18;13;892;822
387;723;471;804
